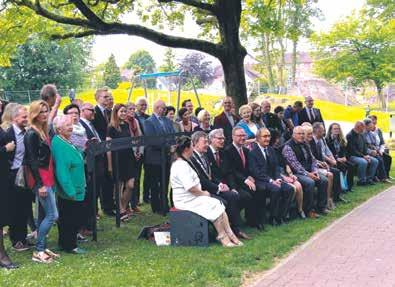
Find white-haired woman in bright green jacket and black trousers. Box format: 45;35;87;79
51;115;86;254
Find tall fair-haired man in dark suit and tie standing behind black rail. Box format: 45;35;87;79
92;87;115;216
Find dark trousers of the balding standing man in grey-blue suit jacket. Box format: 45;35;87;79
145;163;170;214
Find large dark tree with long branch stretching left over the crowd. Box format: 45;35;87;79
3;0;247;109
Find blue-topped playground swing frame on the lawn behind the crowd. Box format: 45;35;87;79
128;71;202;111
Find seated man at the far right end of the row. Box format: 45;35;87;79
363;118;391;183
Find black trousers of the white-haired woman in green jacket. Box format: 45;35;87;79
58;197;83;252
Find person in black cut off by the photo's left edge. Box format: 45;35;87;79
0;128;17;269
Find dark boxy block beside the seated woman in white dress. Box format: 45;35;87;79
170;210;212;247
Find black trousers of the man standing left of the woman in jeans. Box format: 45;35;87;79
9;170;33;245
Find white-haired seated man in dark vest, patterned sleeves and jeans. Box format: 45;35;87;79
282;126;328;218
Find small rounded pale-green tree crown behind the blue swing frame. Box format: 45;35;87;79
125;50;156;88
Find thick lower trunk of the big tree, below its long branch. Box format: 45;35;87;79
221;52;248;111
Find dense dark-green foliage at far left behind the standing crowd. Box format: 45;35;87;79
0;37;91;90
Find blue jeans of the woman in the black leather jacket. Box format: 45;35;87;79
36;186;59;251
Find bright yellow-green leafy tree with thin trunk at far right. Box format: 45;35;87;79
313;10;395;108
